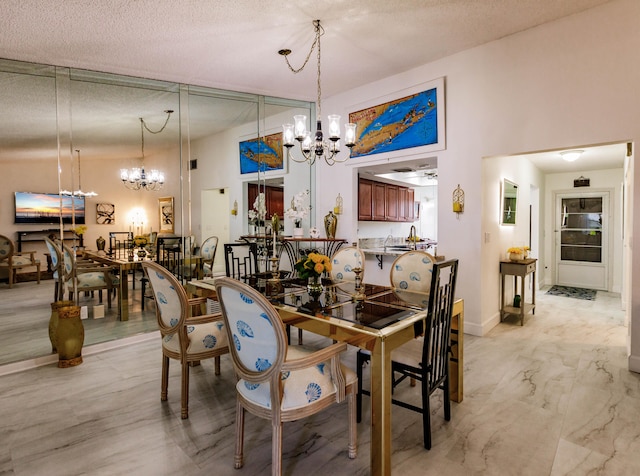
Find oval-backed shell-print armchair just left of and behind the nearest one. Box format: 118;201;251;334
142;261;229;419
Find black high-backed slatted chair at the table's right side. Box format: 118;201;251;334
357;259;458;449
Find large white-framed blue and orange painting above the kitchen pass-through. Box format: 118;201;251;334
349;78;445;159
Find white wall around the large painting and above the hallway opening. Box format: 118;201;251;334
317;0;640;370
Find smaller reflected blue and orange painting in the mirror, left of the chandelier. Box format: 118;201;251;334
240;132;286;175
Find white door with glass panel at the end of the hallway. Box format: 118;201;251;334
555;192;609;290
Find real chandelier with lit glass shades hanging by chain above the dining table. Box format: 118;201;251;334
278;20;356;165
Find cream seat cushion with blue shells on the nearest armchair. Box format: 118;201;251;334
236;346;356;410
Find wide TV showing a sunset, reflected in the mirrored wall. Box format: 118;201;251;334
15;192;84;225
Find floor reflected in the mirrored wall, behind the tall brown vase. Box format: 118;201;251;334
0;274;158;365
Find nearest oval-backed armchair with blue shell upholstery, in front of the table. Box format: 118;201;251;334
216;278;357;475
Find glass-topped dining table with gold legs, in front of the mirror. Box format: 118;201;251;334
187;279;464;475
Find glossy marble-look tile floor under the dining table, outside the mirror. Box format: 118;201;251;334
0;290;640;476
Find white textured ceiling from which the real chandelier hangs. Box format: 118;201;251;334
0;0;624;177
